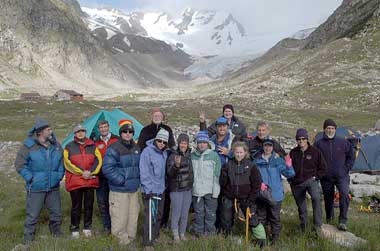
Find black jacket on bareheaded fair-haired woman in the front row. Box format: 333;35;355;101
219;158;262;204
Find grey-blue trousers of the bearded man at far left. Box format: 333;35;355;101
24;189;62;243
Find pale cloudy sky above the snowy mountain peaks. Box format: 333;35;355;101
79;0;342;35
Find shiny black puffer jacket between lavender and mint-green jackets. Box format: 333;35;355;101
166;149;194;192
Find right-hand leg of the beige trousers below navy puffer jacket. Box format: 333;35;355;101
127;192;140;240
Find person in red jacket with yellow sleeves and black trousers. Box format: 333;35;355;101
63;124;103;239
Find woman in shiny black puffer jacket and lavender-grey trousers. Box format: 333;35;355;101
166;133;194;242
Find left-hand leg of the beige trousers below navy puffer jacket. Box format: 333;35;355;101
109;191;128;240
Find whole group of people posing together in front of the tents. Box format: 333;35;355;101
15;104;354;250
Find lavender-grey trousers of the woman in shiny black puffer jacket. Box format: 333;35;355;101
170;190;191;234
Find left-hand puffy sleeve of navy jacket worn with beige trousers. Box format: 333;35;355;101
102;148;125;186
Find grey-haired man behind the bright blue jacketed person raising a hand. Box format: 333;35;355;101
247;121;286;160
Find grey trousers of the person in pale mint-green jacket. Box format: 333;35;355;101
193;194;218;234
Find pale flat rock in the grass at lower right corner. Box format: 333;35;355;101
322;224;368;248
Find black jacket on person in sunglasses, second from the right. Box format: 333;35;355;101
290;144;327;185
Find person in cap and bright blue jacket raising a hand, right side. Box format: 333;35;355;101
254;137;295;244
